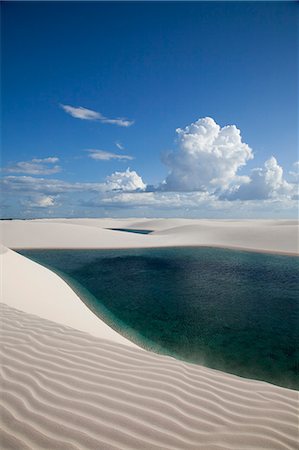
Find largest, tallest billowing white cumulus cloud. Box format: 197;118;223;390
161;117;253;193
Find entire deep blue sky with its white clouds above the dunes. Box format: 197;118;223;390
1;2;299;218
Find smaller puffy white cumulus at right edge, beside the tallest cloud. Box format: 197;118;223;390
224;156;296;200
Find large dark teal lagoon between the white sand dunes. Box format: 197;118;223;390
19;247;299;389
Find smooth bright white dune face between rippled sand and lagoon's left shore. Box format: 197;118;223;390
0;247;137;347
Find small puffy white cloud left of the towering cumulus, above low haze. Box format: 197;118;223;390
105;168;146;192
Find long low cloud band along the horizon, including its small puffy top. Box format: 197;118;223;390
2;169;298;218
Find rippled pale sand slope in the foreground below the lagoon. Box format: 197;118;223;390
0;303;298;450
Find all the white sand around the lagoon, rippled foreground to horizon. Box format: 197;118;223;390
0;219;298;450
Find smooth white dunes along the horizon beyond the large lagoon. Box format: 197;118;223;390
0;219;299;255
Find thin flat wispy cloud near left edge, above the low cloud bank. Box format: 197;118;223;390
3;156;61;175
